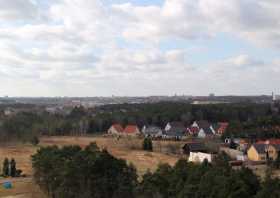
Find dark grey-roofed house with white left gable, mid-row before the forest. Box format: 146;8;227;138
163;122;187;139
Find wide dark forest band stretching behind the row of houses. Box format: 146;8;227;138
0;102;280;141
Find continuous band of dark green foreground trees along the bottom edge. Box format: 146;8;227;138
32;144;280;198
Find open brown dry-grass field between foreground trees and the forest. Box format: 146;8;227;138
0;137;183;198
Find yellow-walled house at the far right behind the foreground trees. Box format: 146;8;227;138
247;144;268;161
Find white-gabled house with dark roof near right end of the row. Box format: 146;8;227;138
192;120;216;138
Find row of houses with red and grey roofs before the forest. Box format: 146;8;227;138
108;120;228;139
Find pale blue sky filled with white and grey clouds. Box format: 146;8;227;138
0;0;280;96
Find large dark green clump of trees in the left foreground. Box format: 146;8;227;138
32;143;137;198
